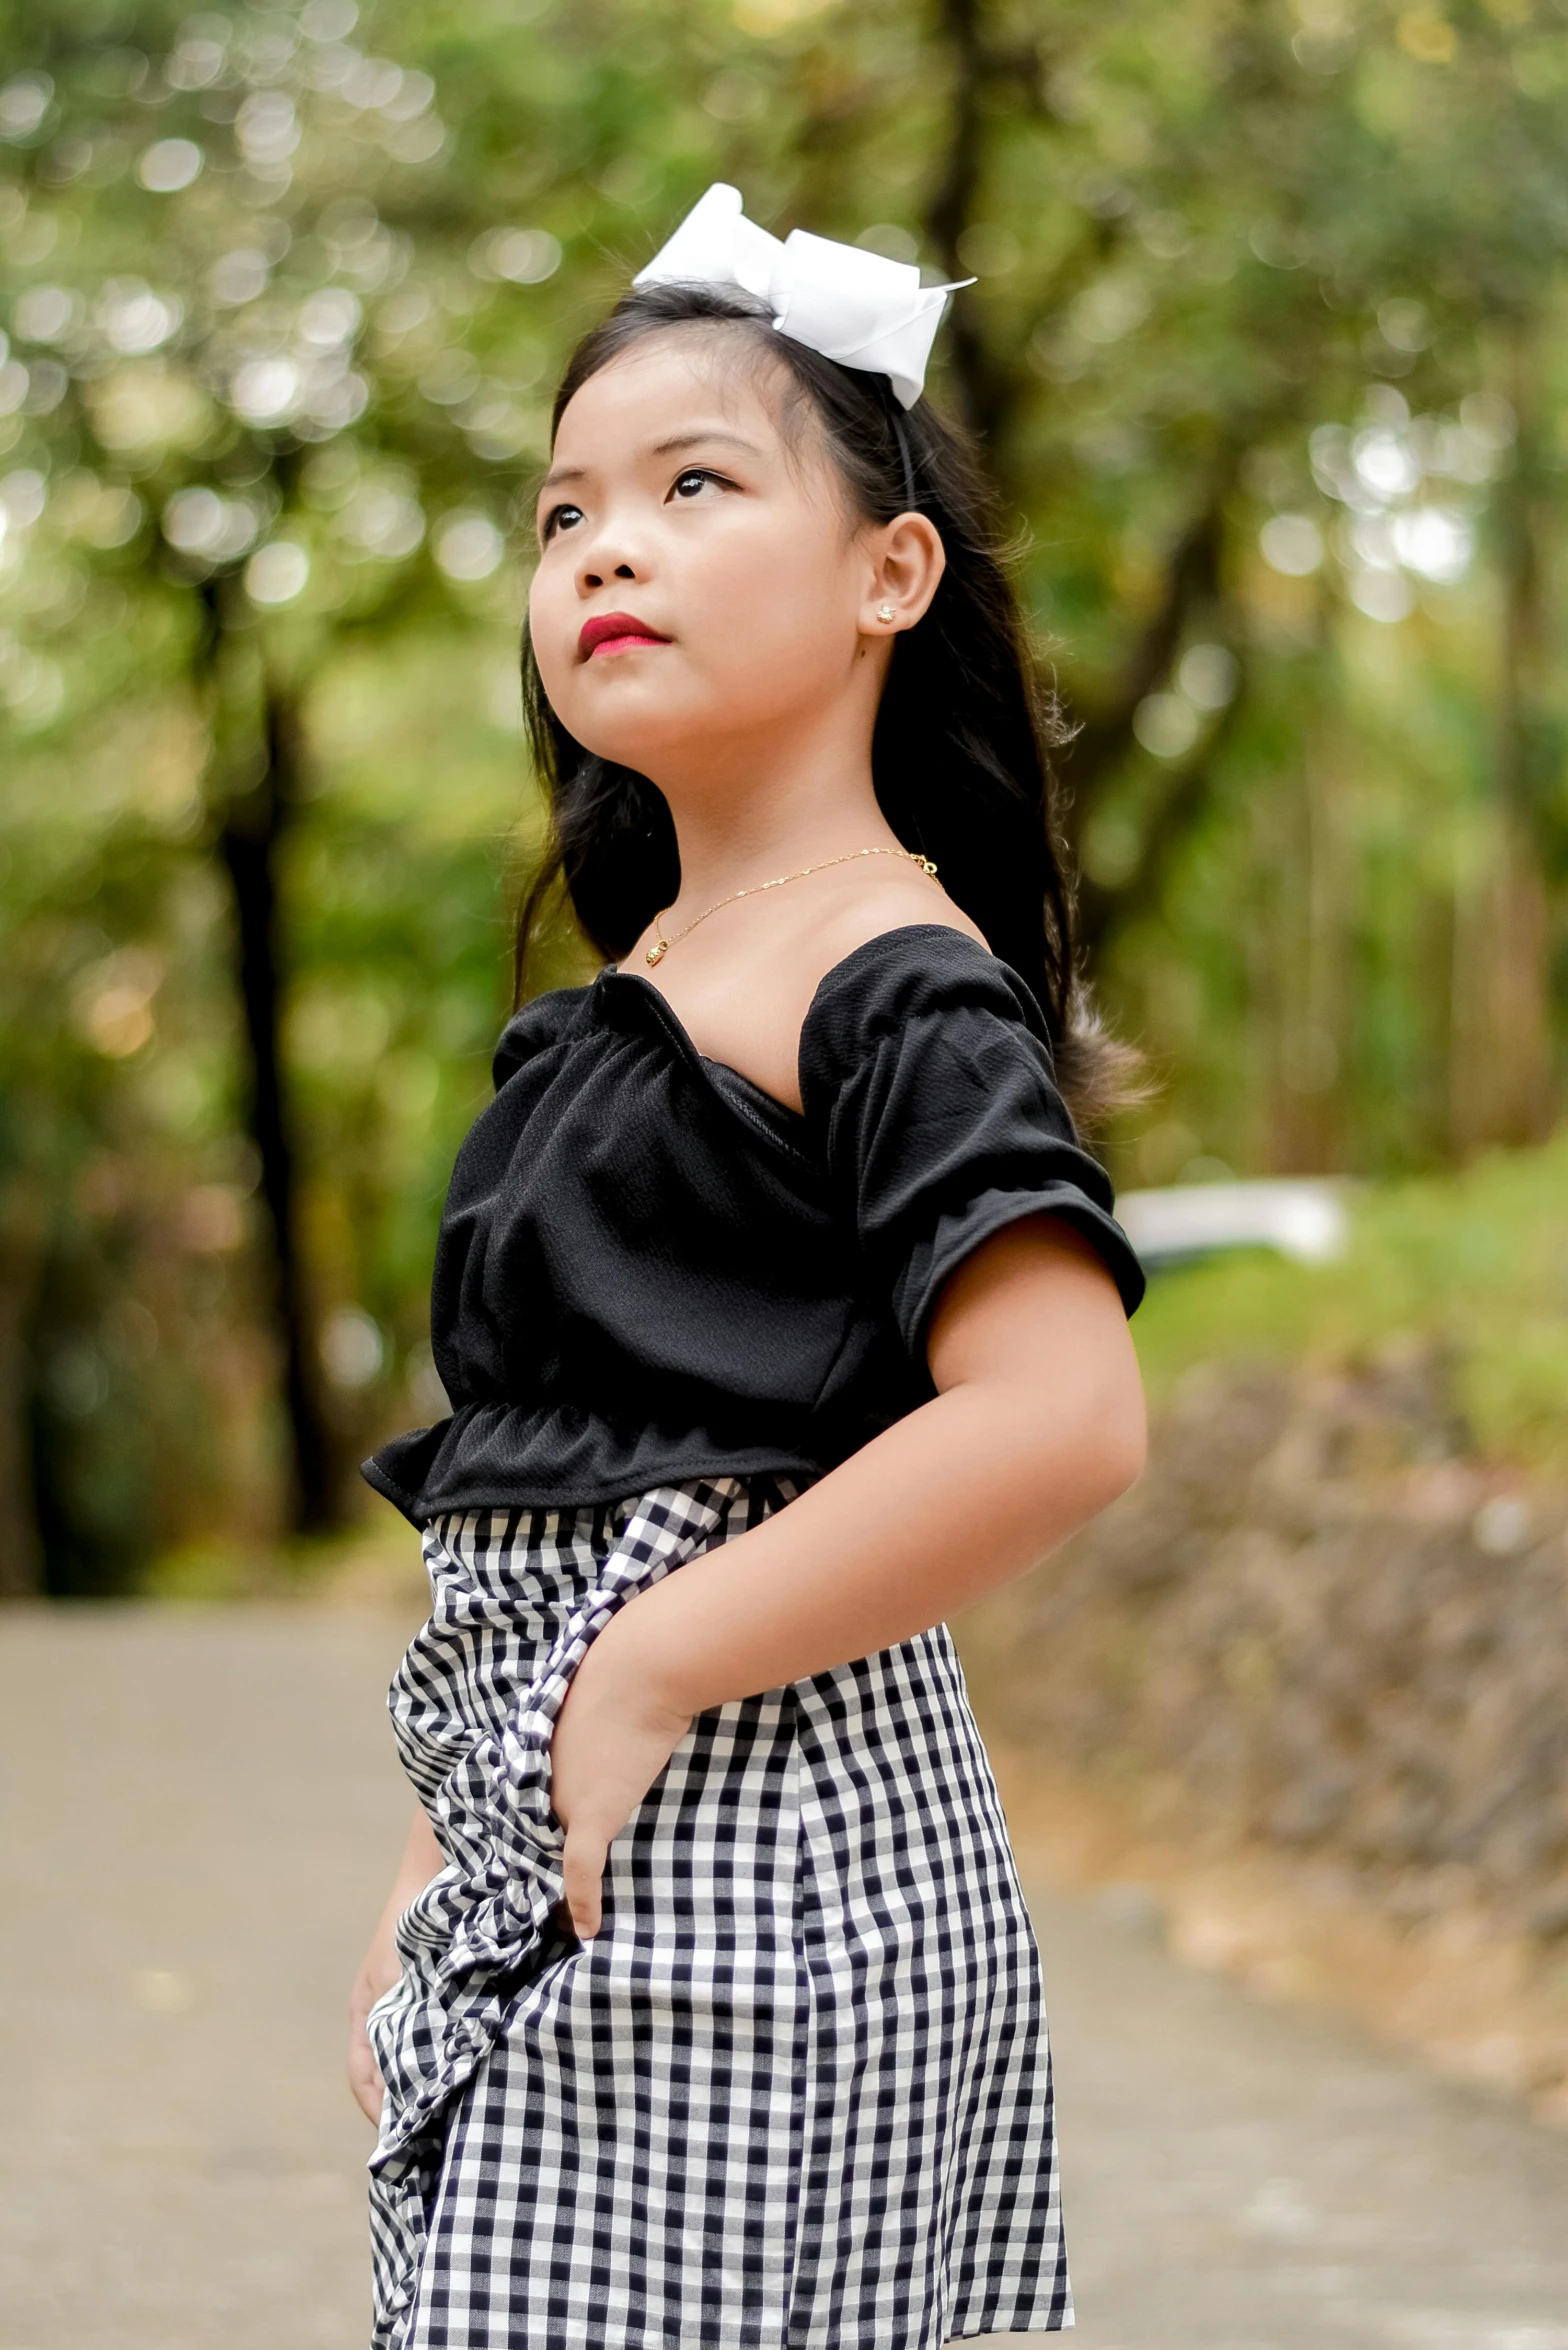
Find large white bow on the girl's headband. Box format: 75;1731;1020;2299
632;179;976;409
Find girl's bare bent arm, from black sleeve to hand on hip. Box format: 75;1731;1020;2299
552;1215;1145;1936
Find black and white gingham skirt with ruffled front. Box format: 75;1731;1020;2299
369;1478;1072;2350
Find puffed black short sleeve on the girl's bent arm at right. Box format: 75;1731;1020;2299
799;924;1145;1356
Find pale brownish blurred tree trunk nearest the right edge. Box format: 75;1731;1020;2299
1453;322;1561;1159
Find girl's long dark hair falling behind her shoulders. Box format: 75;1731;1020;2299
515;284;1138;1128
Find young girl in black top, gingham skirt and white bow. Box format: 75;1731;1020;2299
350;188;1145;2350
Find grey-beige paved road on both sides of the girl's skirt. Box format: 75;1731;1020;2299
0;1607;1568;2350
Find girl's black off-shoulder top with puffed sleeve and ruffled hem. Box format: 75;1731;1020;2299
362;924;1145;1525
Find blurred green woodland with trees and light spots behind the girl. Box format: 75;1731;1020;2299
0;0;1568;1593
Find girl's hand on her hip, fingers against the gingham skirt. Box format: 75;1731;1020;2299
550;1603;691;1941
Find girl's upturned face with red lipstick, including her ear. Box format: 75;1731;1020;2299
529;329;940;780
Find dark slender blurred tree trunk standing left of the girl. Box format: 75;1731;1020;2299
205;596;341;1535
